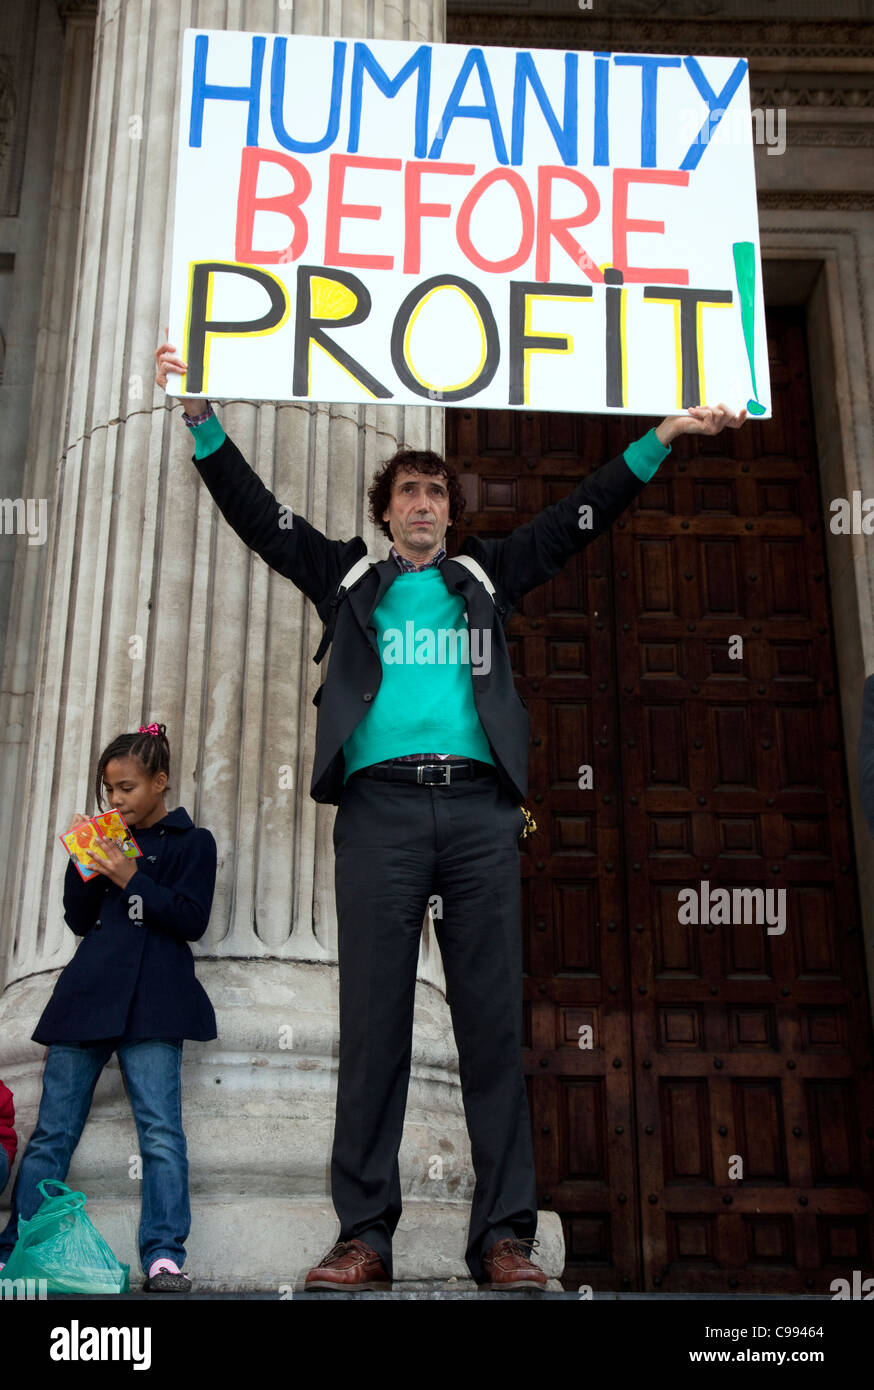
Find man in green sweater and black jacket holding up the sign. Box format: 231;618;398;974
156;343;746;1290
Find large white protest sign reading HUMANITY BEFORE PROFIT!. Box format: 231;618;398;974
171;31;770;416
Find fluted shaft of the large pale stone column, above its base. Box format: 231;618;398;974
6;0;442;984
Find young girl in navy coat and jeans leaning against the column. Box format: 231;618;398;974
0;724;217;1293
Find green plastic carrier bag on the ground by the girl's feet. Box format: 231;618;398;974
1;1177;131;1294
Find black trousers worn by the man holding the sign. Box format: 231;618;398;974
331;777;536;1282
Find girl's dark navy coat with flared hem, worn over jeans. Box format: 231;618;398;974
32;806;217;1043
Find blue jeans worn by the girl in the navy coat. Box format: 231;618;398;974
0;1038;190;1272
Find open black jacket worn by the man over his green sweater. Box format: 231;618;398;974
193;438;645;805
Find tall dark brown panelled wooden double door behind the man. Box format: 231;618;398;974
446;311;874;1293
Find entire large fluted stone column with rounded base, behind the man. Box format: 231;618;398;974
0;0;560;1287
